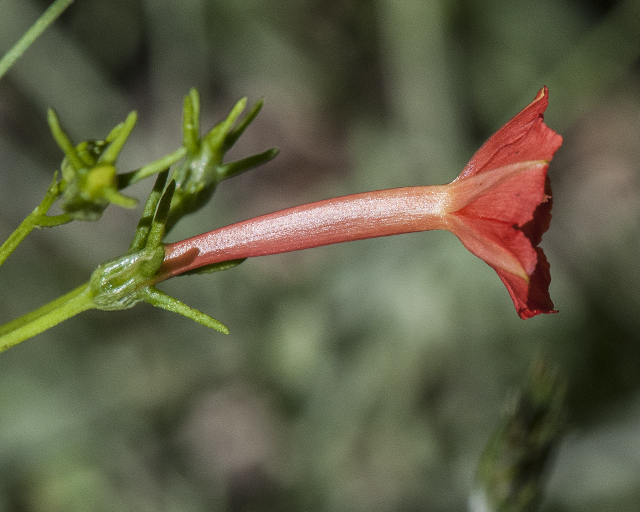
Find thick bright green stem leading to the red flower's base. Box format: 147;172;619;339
0;283;95;352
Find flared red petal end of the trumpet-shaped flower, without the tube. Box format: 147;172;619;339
442;87;562;318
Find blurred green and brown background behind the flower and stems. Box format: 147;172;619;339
0;0;640;512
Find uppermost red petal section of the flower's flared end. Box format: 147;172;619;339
456;87;562;180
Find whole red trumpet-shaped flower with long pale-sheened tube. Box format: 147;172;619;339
158;87;562;318
